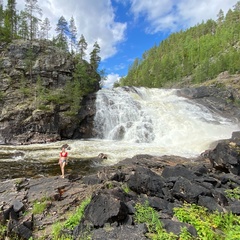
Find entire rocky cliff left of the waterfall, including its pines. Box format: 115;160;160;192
0;0;101;144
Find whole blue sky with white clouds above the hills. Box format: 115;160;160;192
3;0;237;87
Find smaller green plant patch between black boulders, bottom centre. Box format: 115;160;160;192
134;203;178;240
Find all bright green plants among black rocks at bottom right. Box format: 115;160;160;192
134;203;240;240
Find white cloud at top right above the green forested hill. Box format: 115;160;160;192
130;0;237;33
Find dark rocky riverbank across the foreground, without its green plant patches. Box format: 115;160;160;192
0;132;240;240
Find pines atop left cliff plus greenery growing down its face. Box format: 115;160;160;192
0;0;104;114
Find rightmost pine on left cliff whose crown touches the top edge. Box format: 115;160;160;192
25;0;42;41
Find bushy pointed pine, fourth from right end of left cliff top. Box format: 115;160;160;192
55;16;69;51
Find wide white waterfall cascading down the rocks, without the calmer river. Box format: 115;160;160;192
95;88;239;156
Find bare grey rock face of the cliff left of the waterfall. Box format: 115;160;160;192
0;40;99;144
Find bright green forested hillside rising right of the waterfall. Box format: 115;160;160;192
119;1;240;87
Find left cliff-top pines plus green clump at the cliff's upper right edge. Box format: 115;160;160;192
0;0;103;98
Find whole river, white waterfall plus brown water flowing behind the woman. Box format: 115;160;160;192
0;88;240;178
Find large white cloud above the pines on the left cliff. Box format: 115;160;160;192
4;0;127;60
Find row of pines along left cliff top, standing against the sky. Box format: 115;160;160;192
0;0;101;70
